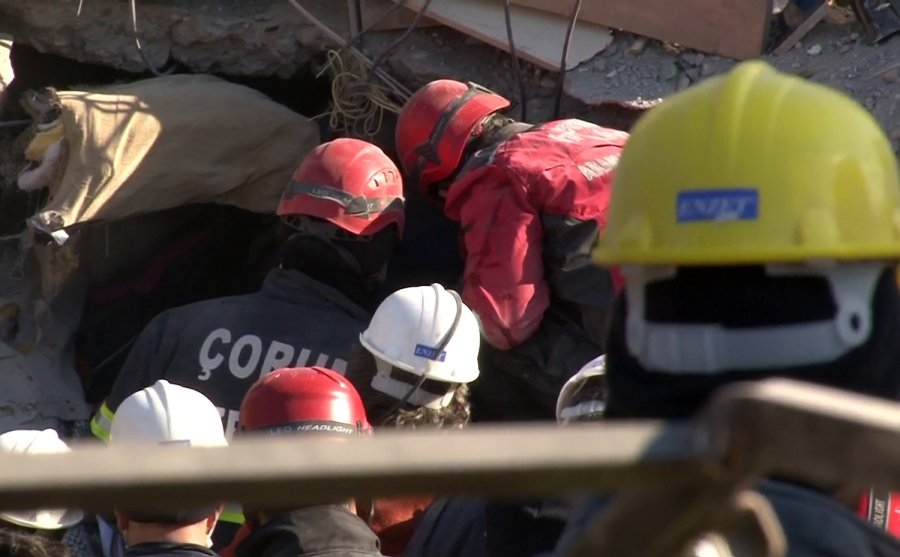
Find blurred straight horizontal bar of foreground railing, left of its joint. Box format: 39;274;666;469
0;422;704;510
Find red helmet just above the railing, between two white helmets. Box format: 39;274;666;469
238;367;372;435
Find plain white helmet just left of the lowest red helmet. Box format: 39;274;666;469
109;379;227;447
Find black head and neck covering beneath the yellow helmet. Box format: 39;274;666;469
606;268;900;419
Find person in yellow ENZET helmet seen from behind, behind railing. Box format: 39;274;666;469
558;61;900;557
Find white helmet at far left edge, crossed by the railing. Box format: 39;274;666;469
0;429;84;530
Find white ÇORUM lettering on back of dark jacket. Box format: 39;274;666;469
197;328;347;381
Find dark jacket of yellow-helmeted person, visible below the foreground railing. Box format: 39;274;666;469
554;480;900;557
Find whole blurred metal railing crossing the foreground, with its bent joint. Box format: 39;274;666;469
0;379;900;557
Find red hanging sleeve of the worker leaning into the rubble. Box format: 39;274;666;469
459;170;550;350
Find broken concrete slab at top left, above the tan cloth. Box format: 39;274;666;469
0;0;348;77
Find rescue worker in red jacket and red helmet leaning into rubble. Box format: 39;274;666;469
396;79;628;420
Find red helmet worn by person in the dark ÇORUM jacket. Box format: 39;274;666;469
277;138;405;236
